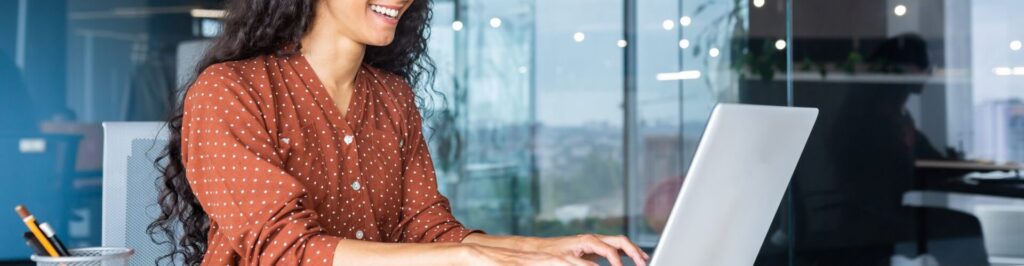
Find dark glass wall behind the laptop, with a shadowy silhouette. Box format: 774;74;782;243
770;0;1024;265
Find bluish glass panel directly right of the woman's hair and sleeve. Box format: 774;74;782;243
430;1;537;233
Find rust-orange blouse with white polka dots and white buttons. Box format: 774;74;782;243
181;51;473;265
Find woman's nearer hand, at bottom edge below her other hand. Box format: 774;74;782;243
460;243;597;266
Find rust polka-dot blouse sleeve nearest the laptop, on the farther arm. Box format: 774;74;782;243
399;83;481;242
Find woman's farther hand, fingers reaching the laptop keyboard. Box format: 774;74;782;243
463;233;650;266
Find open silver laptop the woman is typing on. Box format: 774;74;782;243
650;104;818;266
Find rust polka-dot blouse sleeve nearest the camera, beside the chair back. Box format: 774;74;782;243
181;68;341;265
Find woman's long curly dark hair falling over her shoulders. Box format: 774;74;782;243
147;0;438;265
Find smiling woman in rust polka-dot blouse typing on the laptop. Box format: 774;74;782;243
151;0;648;265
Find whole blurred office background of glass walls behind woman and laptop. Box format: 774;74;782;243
0;0;1024;265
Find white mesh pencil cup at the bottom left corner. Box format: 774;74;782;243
32;248;135;266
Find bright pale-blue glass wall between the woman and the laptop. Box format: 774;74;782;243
432;0;785;248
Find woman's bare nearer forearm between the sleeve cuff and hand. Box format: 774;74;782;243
333;239;467;266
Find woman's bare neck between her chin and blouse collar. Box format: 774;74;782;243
301;15;367;94
